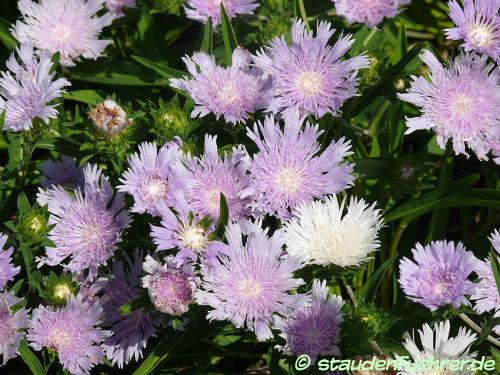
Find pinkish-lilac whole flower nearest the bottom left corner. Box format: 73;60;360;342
26;295;109;375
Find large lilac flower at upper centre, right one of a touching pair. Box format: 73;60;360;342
253;21;369;118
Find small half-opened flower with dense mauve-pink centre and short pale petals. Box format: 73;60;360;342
142;255;199;316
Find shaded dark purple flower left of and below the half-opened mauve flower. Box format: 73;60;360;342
101;250;159;368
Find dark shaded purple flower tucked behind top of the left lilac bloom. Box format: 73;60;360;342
40;155;85;190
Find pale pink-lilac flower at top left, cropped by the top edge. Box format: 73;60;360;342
12;0;113;66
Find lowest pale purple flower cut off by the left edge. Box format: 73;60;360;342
0;293;29;365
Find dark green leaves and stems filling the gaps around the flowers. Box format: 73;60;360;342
0;0;500;374
